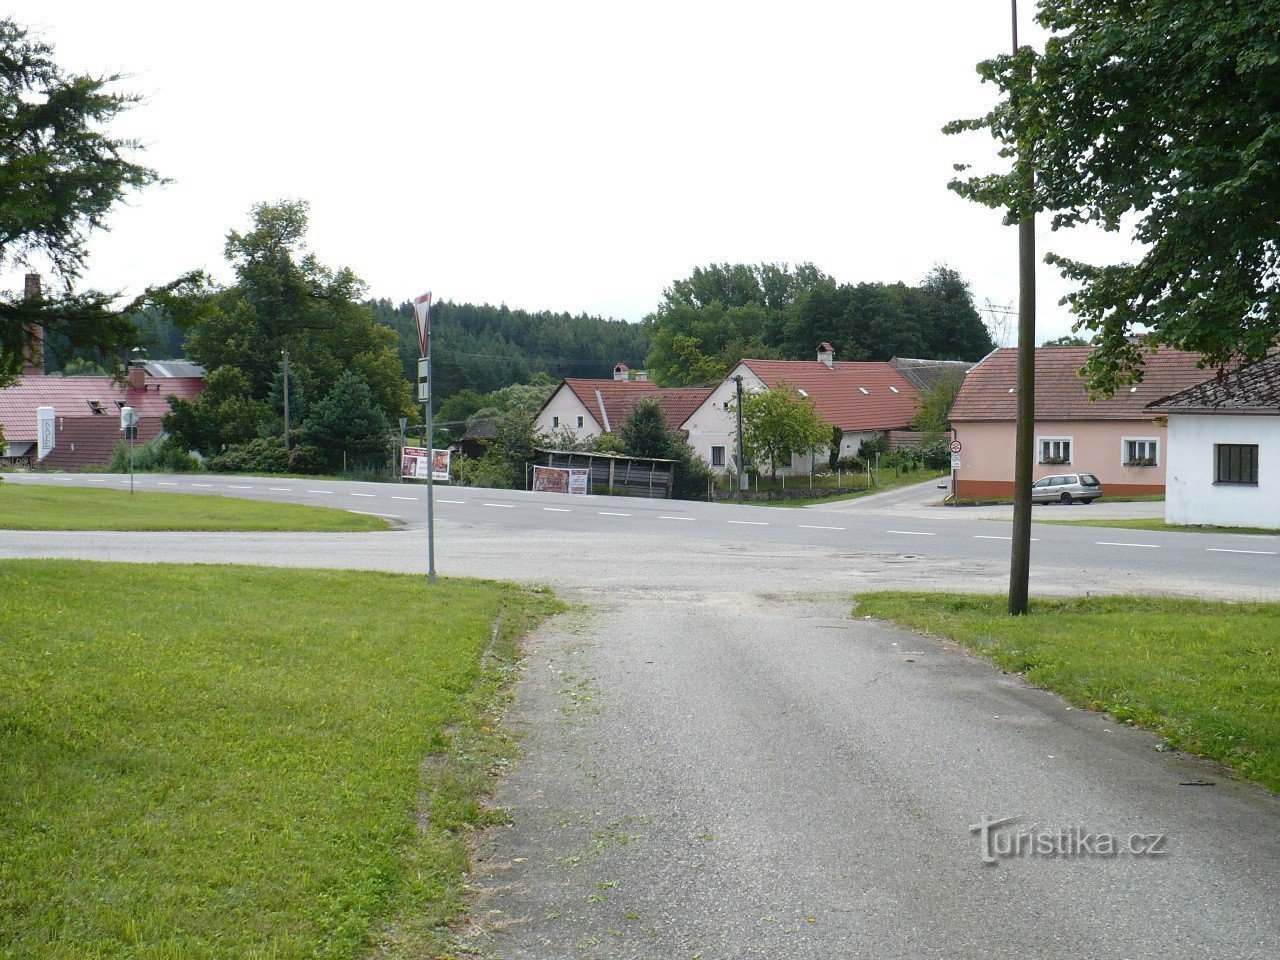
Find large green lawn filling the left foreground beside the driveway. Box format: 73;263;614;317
0;561;557;960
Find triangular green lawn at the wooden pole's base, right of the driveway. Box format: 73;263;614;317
858;591;1280;790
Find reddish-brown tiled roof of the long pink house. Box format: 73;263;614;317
951;347;1208;422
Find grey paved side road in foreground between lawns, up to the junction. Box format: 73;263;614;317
470;591;1280;960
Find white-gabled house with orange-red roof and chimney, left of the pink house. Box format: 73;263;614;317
681;343;920;472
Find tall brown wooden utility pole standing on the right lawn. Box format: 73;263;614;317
1009;0;1036;617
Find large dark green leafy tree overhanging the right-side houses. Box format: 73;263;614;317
946;0;1280;392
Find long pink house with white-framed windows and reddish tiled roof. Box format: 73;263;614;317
951;347;1208;499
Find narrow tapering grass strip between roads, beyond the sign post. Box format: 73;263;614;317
0;483;387;531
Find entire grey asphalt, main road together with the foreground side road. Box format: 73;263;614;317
0;476;1280;960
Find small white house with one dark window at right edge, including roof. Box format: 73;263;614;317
1151;355;1280;529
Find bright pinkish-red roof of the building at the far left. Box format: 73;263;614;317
0;376;205;442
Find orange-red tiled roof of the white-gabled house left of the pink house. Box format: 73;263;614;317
742;360;920;430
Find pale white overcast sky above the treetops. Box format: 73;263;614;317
6;0;1132;348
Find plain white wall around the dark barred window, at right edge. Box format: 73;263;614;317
1165;413;1280;529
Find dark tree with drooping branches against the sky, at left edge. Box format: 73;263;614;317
0;18;196;387
